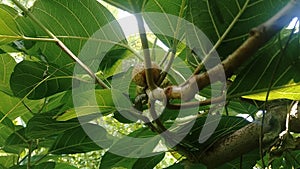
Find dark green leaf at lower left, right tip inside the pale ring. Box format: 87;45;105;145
50;124;112;154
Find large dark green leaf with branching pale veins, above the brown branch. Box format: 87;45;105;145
186;0;289;58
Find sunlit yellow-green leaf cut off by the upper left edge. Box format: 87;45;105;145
0;4;20;45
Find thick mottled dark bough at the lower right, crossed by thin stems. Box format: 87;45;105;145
197;102;300;168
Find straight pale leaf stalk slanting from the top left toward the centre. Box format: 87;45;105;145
12;0;109;89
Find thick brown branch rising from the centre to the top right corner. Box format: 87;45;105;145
165;0;300;101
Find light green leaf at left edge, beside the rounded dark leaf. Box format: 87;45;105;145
0;54;16;94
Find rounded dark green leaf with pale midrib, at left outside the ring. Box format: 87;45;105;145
10;61;72;99
